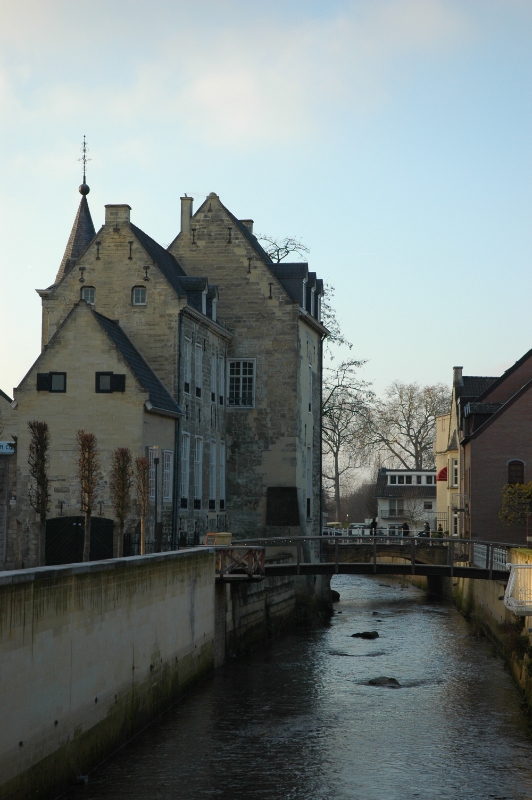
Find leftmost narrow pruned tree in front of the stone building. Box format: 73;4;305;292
28;420;50;566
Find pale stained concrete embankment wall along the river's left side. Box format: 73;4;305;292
0;549;215;800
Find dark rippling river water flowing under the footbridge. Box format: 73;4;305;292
63;576;532;800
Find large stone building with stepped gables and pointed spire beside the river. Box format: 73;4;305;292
6;183;327;567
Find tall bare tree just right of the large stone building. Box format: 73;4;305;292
322;360;373;519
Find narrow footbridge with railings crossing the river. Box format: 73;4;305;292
216;535;523;583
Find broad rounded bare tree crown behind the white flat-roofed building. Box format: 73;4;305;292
364;381;451;469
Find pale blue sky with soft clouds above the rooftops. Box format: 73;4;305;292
0;0;532;395
